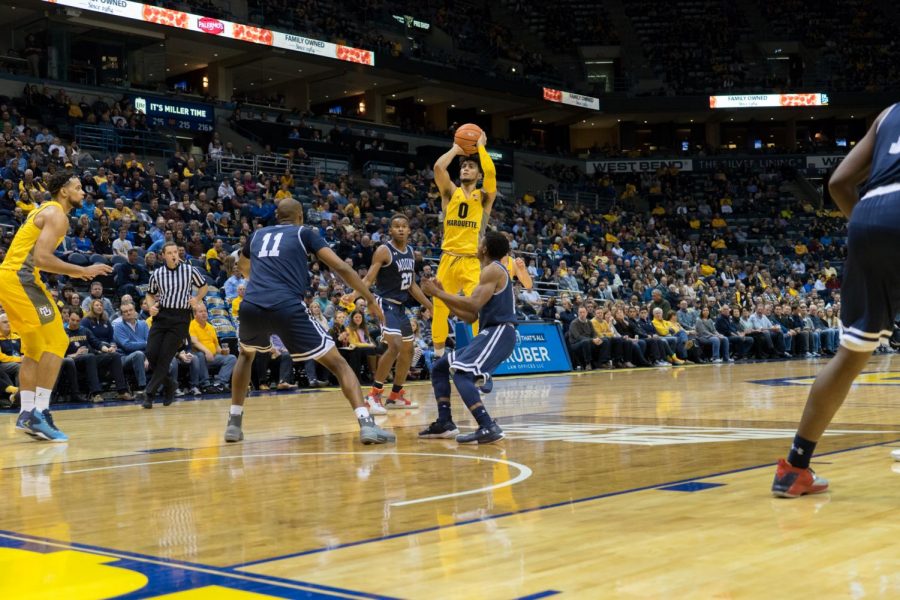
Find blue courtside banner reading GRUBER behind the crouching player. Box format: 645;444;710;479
456;321;572;375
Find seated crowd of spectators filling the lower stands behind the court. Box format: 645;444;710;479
0;78;884;412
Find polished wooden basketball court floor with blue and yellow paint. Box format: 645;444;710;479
0;356;900;599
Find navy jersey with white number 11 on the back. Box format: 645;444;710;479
243;225;328;308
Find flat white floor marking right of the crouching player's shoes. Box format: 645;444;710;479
503;423;900;446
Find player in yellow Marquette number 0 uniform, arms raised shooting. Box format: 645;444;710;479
431;125;497;358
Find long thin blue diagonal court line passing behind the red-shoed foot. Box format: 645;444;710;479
226;439;900;572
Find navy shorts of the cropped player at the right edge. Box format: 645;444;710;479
841;193;900;352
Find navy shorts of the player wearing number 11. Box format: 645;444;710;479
238;300;334;361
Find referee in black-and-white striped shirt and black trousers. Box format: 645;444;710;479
141;242;207;408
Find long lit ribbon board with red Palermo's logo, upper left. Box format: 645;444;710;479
43;0;375;67
